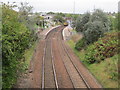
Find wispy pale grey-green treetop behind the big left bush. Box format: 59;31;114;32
18;2;36;30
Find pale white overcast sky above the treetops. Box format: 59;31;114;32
3;0;119;13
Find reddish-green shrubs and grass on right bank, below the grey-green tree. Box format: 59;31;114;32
68;31;120;88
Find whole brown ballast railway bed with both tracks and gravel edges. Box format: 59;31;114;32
24;26;102;90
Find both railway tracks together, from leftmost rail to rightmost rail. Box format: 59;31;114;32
41;27;101;90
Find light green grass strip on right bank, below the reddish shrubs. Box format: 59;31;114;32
68;40;119;88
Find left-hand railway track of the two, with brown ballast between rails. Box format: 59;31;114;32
41;28;61;89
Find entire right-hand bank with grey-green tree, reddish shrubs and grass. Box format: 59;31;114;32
68;10;120;88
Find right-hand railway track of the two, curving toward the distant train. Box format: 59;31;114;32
49;26;90;89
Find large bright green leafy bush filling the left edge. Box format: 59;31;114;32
2;4;35;88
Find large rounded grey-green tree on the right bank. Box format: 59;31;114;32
84;9;111;44
